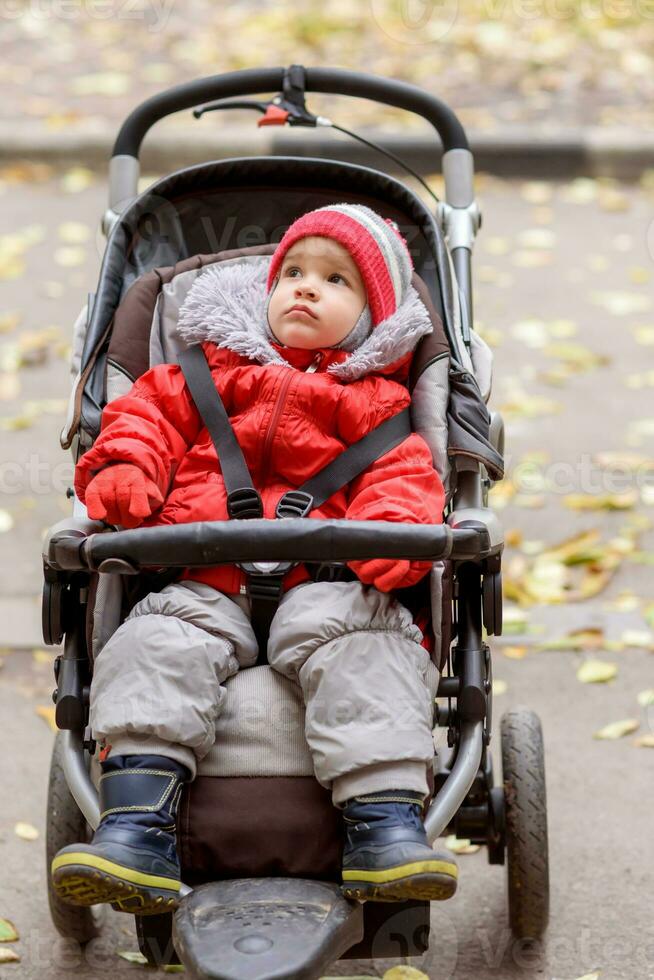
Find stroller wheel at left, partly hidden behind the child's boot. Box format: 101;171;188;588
45;732;107;944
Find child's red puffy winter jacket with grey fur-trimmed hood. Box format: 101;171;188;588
75;262;445;594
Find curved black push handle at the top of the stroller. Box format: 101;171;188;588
112;68;468;157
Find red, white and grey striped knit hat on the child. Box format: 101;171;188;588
266;204;413;327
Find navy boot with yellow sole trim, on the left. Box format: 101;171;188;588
51;755;190;915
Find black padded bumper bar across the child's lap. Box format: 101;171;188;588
44;518;494;574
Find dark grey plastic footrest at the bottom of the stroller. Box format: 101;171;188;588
173;878;363;980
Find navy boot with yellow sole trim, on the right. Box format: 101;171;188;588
341;790;458;902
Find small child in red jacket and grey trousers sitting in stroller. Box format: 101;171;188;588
52;204;457;914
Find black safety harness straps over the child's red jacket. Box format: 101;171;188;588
179;344;411;662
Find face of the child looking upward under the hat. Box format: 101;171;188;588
268;235;367;350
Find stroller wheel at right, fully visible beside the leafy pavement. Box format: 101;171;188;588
501;707;550;939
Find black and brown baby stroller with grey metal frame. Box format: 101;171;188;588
43;65;549;980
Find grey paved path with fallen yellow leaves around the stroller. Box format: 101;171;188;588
0;174;654;980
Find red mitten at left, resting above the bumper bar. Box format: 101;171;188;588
85;463;163;527
